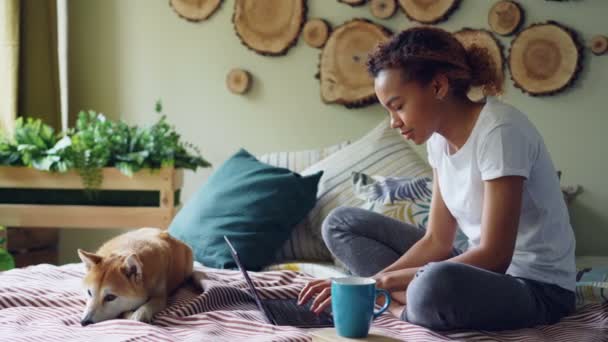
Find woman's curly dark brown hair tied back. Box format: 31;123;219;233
367;27;502;96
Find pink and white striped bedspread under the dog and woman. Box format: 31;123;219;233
0;264;608;342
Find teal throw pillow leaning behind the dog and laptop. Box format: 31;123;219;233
169;149;323;271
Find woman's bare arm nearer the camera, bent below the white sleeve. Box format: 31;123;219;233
377;176;524;291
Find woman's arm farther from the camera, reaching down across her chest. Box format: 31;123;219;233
376;169;456;277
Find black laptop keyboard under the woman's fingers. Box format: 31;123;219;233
263;299;333;325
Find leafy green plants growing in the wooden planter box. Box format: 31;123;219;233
0;101;211;206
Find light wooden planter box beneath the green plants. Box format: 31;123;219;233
0;166;183;230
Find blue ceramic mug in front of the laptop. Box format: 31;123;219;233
331;277;391;338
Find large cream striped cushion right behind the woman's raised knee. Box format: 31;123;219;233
279;119;432;261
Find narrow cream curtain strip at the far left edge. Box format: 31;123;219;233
0;0;20;135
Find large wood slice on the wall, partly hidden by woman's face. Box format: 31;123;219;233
319;19;392;108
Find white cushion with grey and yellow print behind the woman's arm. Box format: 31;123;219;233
352;172;468;251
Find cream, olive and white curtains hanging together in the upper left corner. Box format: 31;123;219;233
0;0;68;135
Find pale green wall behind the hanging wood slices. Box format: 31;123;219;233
61;0;608;262
